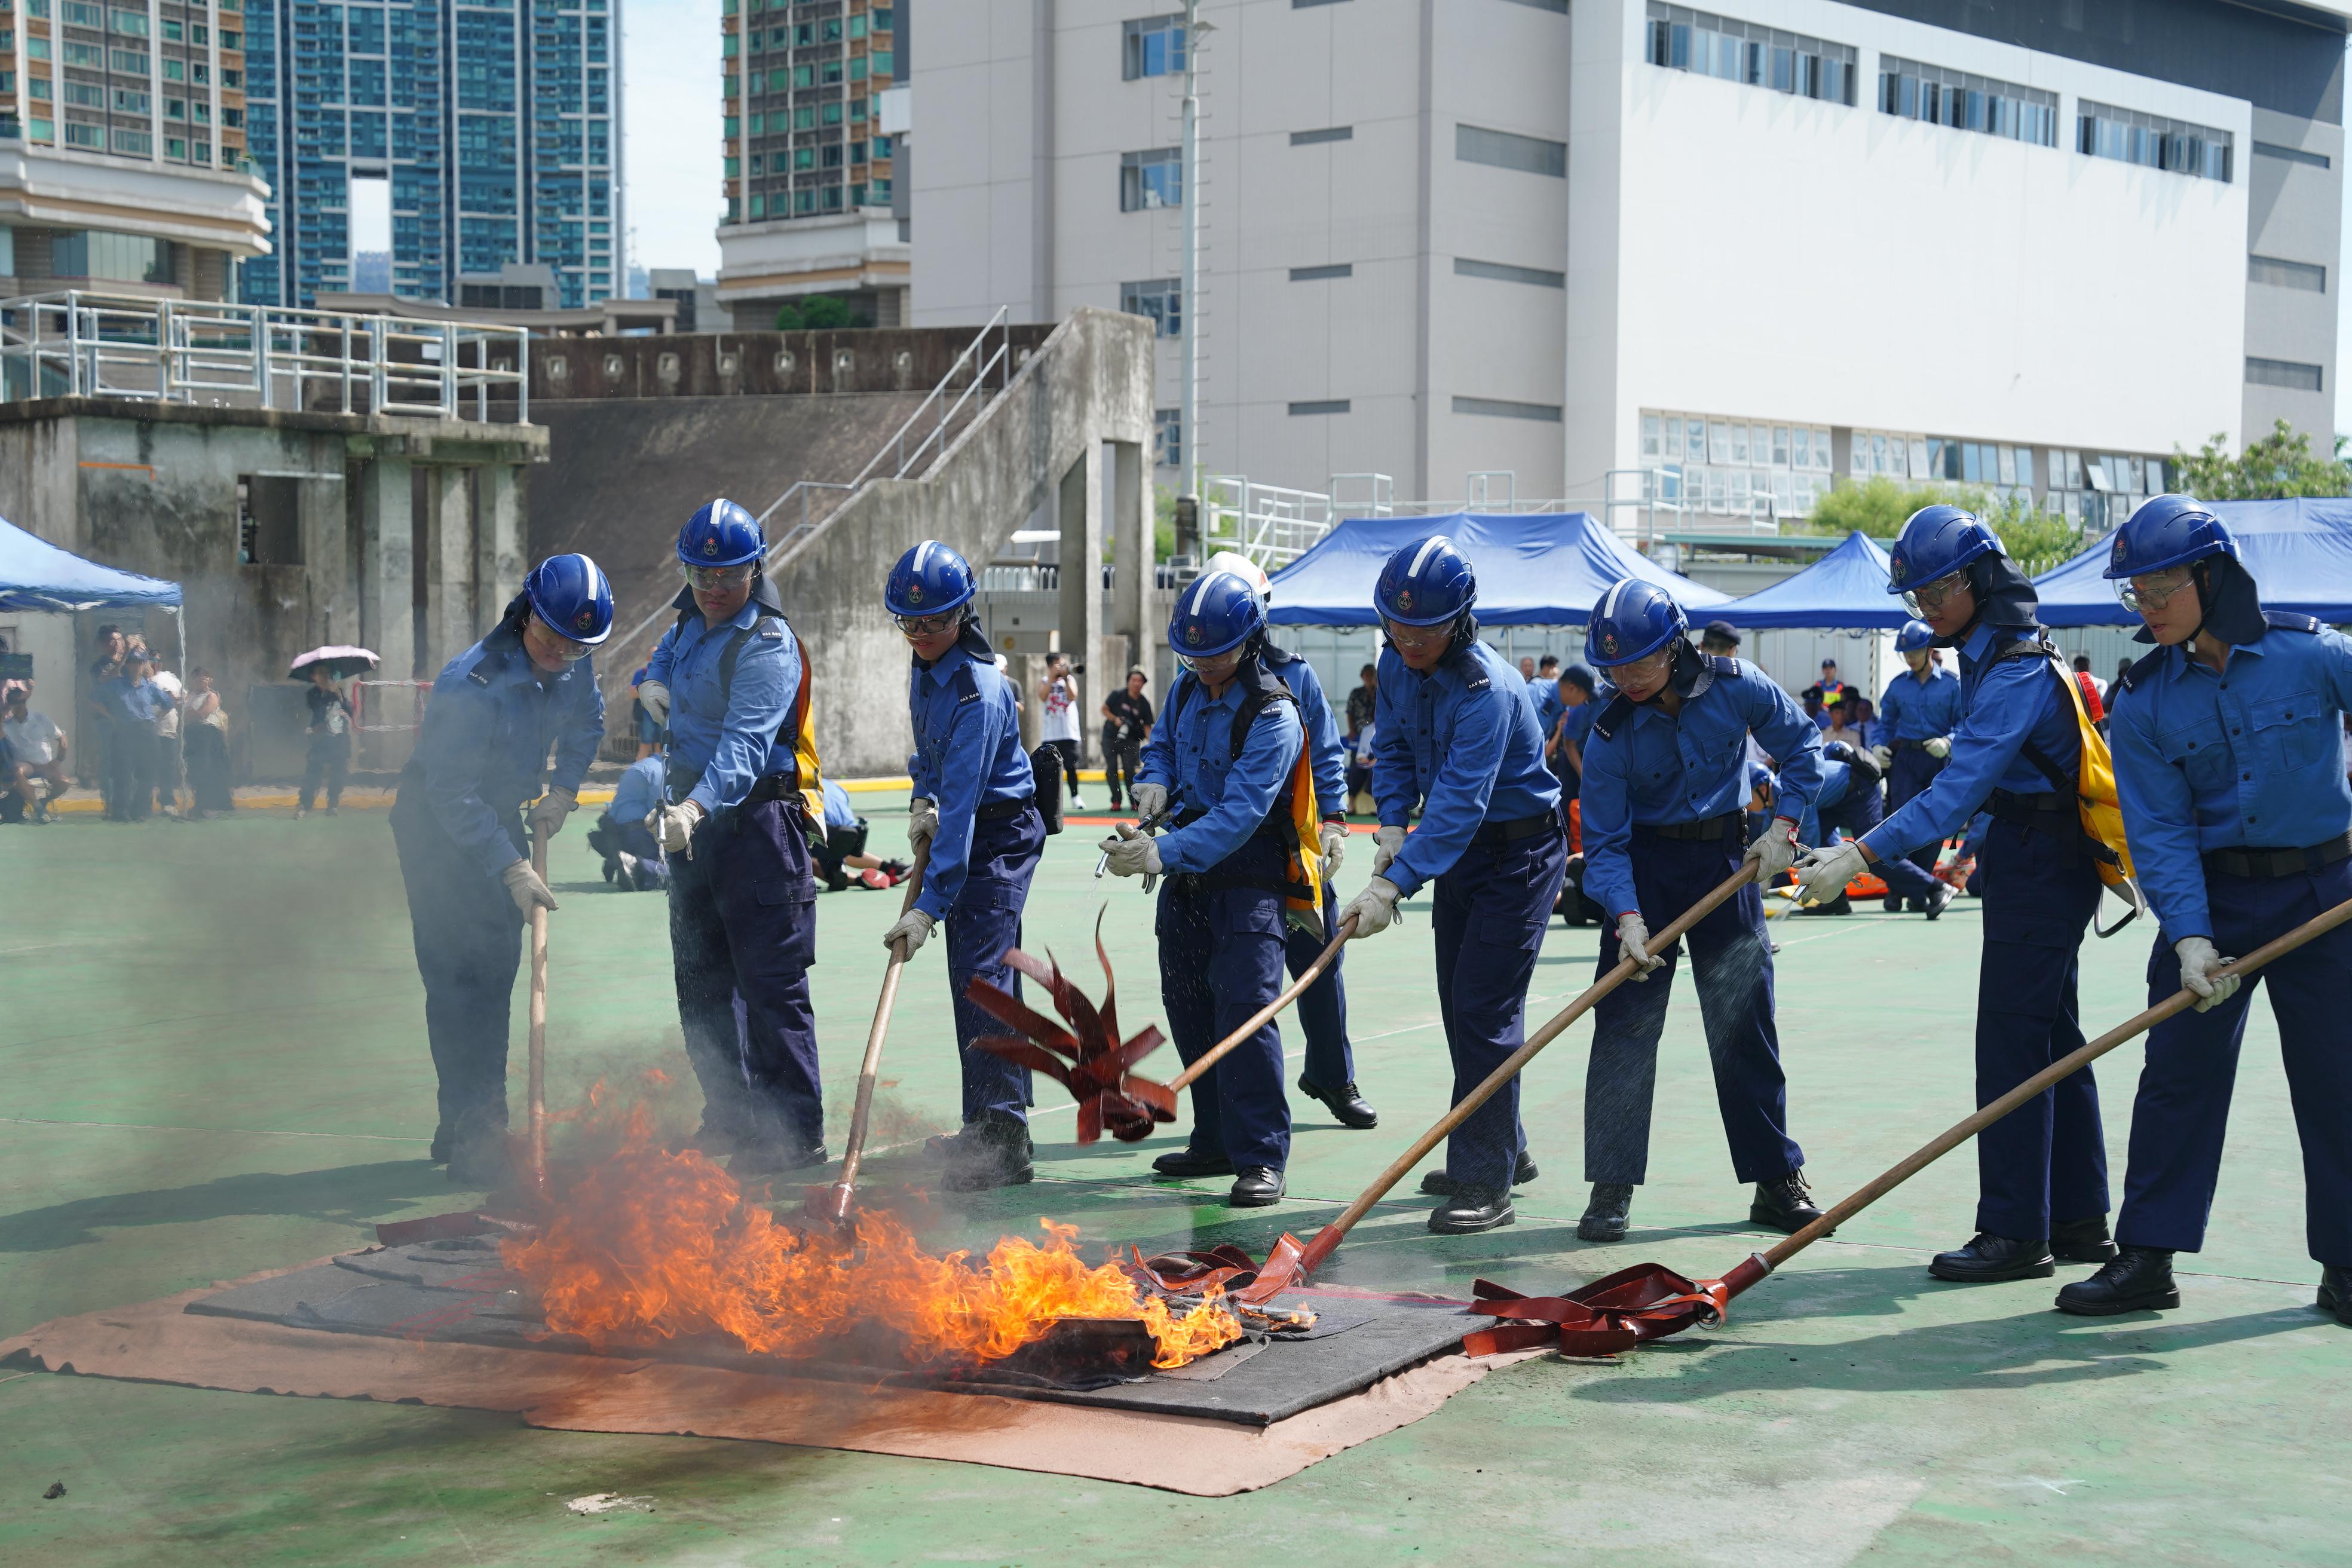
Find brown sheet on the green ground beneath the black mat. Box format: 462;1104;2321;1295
0;1265;1543;1497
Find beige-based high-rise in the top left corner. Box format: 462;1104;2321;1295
0;0;271;299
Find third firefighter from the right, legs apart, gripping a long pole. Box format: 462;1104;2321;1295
1576;578;1820;1241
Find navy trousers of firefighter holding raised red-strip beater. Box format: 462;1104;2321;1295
1157;837;1291;1171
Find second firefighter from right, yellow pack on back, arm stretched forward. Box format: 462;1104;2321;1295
1797;506;2114;1284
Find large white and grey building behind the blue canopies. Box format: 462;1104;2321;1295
901;0;2345;524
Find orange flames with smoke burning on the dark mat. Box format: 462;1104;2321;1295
501;1074;1242;1366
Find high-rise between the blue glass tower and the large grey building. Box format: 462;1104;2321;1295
717;0;908;327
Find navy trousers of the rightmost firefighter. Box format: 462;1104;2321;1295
2114;860;2352;1267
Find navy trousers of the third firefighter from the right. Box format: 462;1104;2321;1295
1585;828;1804;1187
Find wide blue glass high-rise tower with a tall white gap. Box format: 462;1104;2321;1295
242;0;628;310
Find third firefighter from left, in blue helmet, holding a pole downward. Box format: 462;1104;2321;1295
882;538;1045;1192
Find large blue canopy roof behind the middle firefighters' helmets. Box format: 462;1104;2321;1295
1272;513;1731;625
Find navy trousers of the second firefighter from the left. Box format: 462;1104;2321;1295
670;800;826;1150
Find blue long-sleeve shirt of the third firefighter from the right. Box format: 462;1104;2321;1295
1581;659;1820;917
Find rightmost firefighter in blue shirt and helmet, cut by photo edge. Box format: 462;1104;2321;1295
2058;496;2352;1324
